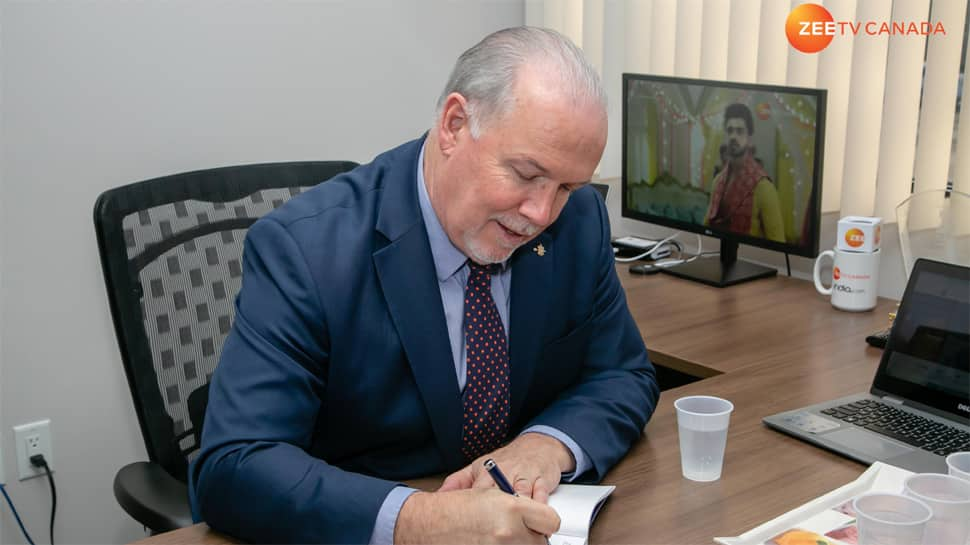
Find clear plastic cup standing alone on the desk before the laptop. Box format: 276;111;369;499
674;396;734;482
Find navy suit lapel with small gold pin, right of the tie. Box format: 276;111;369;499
509;233;556;423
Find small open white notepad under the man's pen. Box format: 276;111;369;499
549;484;616;545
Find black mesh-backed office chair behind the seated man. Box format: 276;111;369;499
94;161;357;533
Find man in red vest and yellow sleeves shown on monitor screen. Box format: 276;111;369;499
704;103;785;242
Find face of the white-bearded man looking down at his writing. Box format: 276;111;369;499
429;68;606;264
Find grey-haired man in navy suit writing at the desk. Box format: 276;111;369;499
190;28;659;543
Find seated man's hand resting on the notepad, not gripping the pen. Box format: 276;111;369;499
438;433;576;503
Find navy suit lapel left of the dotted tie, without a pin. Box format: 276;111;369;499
374;141;464;468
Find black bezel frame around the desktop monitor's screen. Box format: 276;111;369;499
620;72;828;258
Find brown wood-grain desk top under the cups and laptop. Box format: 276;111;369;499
132;267;895;545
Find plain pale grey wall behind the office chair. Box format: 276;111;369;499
0;0;524;543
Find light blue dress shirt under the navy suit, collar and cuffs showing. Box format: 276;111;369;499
370;142;591;545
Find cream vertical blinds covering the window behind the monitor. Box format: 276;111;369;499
525;0;970;222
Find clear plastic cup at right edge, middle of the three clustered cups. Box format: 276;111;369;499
903;473;970;545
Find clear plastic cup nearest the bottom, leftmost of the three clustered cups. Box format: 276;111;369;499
852;492;933;545
